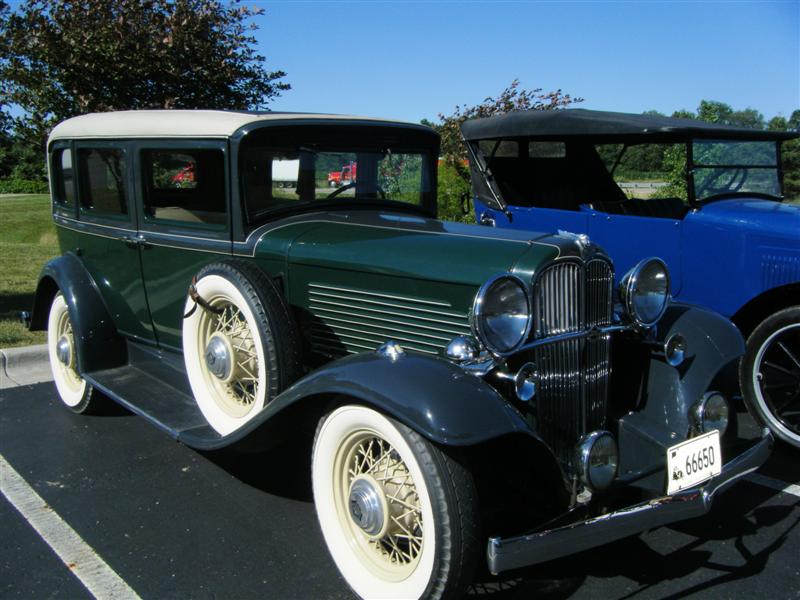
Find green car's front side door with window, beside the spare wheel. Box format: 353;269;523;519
135;140;232;350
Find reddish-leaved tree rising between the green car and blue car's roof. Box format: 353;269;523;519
432;79;583;221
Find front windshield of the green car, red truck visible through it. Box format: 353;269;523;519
240;125;435;222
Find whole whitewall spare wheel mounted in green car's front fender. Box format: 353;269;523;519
183;262;300;435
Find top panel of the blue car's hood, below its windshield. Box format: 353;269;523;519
697;198;800;240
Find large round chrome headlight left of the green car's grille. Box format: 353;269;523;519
472;275;531;354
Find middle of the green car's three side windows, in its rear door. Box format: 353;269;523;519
78;148;128;216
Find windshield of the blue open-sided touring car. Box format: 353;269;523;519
692;140;781;201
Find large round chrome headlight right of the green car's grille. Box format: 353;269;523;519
620;258;669;327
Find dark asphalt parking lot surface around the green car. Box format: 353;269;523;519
0;383;800;599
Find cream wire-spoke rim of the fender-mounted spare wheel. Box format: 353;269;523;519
197;295;261;418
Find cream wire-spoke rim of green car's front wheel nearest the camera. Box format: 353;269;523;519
333;429;424;581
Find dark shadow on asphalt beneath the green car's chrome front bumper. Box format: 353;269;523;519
469;485;800;599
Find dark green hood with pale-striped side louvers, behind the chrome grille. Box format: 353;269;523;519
255;211;599;356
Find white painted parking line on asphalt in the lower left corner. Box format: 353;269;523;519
0;454;141;600
